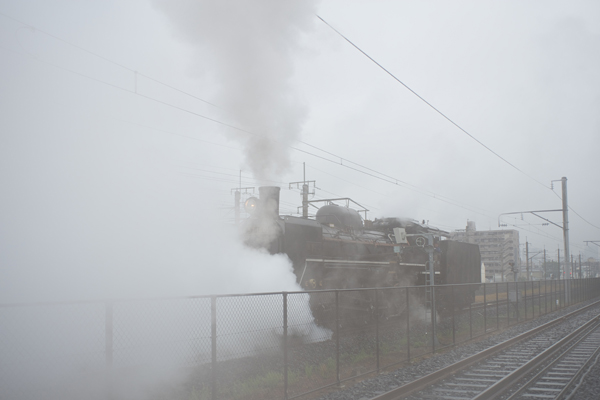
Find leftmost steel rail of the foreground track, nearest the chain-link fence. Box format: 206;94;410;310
371;301;600;400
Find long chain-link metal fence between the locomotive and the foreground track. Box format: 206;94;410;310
0;278;600;399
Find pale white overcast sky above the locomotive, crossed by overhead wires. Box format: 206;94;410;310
0;0;600;300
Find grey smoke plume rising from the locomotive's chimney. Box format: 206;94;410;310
156;0;317;179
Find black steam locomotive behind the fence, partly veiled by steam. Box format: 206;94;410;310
245;186;481;326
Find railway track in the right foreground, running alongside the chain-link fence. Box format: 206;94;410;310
372;302;600;400
